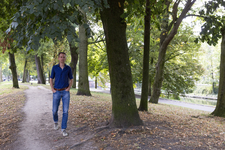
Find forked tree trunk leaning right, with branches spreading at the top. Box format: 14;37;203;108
149;0;196;104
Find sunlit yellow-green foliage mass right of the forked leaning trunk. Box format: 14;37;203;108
162;25;204;95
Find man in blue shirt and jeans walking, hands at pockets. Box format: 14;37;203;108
50;52;73;136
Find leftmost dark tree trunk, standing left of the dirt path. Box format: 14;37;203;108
9;52;19;88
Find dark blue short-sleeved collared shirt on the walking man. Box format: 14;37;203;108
50;64;73;89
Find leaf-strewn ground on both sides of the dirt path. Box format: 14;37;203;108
0;85;225;150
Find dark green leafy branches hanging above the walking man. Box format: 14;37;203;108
12;0;107;50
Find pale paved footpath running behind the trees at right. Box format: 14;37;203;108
90;88;215;112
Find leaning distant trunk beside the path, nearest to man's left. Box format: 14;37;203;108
35;55;45;84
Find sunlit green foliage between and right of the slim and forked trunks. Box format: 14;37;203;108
127;18;203;94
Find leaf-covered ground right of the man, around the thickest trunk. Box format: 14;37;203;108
69;89;225;150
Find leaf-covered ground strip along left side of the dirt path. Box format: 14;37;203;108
0;85;26;149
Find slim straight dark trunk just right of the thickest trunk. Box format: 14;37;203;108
138;0;151;111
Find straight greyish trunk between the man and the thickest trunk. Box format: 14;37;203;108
77;21;91;96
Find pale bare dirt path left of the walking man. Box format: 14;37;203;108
10;86;53;150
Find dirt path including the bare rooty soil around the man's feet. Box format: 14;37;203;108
9;86;97;150
